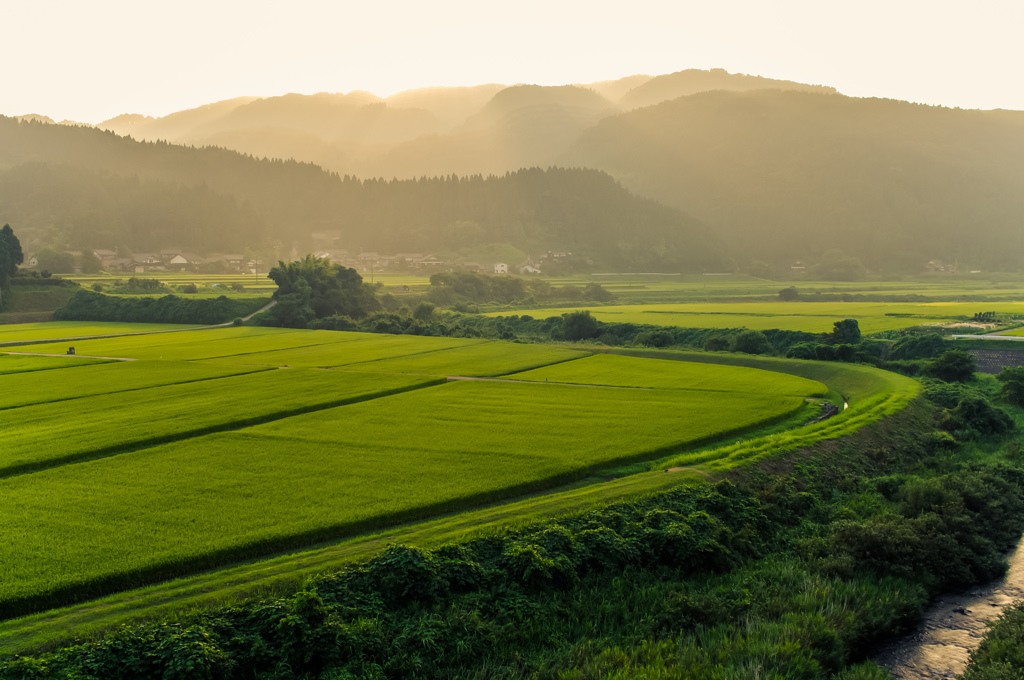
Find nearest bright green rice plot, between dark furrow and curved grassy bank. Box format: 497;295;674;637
0;372;803;614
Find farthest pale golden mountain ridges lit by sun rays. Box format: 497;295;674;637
90;69;835;177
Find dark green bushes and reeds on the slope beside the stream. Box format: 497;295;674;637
8;385;1024;680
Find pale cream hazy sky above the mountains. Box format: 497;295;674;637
0;0;1024;123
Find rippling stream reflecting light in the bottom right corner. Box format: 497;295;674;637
873;540;1024;680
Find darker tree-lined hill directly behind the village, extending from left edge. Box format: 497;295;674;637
0;118;725;270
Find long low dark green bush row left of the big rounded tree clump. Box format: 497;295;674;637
53;290;267;324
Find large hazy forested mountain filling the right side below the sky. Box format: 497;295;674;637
557;91;1024;272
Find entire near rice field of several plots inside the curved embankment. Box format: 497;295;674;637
0;327;827;617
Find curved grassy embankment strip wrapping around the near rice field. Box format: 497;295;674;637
0;351;920;652
